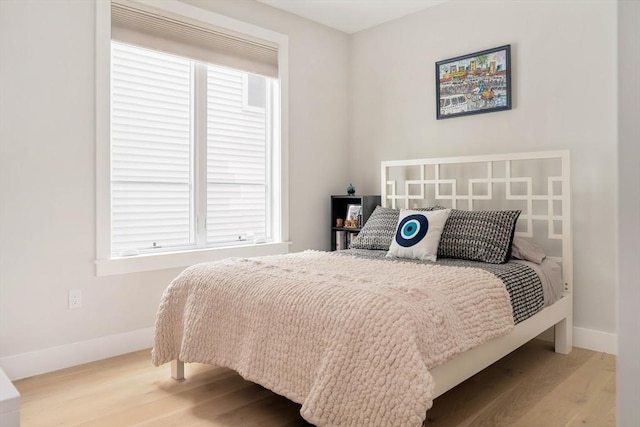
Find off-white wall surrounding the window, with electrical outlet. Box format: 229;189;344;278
0;0;348;377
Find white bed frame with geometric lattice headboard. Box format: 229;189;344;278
171;151;573;397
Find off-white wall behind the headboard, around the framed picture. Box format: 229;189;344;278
350;0;617;345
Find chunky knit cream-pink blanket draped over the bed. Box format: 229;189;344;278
153;251;513;427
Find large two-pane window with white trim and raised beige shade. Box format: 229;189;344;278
97;0;287;275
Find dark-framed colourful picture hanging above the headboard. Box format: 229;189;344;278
436;45;511;120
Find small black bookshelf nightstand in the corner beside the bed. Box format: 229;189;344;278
330;194;381;251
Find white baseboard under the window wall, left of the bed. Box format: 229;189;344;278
0;327;154;381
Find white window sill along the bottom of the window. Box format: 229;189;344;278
95;242;290;277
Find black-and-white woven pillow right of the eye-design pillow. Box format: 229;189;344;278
438;209;520;264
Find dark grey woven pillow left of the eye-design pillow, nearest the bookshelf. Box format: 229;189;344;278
351;206;443;251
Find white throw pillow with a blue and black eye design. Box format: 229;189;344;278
387;209;451;261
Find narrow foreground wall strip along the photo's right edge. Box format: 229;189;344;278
616;0;640;427
